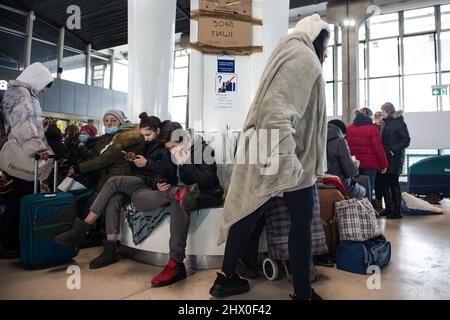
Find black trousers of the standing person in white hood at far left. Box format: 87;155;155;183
0;178;34;250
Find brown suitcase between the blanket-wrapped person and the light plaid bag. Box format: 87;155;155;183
319;188;345;258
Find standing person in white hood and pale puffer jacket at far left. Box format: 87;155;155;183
0;62;54;257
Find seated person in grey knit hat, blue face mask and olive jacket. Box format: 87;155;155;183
71;109;143;193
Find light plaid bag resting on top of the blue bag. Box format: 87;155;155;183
336;198;381;241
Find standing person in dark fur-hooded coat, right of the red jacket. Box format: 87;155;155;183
380;102;411;219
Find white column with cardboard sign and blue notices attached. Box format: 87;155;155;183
189;0;289;133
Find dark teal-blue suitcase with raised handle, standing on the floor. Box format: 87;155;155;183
20;155;78;268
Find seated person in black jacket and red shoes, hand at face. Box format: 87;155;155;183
131;122;223;287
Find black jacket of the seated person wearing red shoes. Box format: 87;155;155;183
150;136;224;209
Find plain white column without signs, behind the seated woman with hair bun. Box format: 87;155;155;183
127;0;176;121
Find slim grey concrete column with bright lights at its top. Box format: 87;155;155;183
327;0;373;123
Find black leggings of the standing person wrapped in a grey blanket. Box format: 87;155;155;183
222;187;314;299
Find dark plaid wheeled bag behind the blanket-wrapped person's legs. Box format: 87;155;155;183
265;188;328;261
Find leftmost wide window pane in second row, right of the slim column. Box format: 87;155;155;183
369;38;399;77
